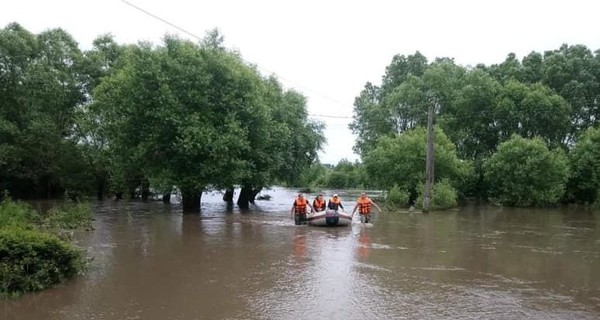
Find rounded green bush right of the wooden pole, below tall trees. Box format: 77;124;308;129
484;135;569;207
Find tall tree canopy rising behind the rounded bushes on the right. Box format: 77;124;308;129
350;45;600;204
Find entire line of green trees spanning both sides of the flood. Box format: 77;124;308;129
0;23;600;210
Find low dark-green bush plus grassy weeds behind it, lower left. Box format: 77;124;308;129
0;197;91;296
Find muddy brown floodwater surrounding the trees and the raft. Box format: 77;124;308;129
0;188;600;320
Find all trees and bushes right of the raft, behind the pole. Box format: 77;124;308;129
350;45;600;206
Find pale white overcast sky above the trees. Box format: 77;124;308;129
0;0;600;163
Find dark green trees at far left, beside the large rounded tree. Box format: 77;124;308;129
0;23;87;198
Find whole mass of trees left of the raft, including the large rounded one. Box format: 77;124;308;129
0;23;324;210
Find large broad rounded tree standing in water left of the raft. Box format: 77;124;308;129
87;33;323;211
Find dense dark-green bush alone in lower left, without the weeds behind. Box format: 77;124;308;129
0;228;83;296
